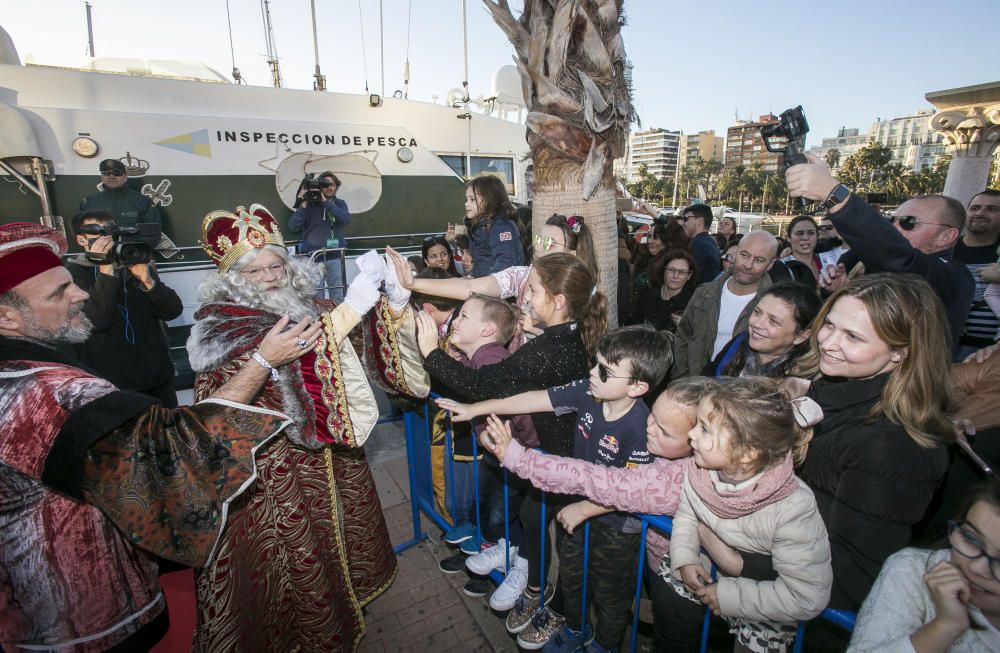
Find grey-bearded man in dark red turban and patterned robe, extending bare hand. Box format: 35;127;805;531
0;223;320;653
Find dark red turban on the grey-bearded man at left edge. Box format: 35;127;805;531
0;222;66;293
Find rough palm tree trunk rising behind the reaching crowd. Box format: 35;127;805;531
483;0;635;326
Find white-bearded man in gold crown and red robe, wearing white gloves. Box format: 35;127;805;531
187;204;429;652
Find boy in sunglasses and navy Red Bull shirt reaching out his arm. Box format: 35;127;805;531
438;326;672;651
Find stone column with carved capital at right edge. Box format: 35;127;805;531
930;104;1000;206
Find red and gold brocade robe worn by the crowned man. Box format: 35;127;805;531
188;302;426;653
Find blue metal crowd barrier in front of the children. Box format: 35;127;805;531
395;394;857;653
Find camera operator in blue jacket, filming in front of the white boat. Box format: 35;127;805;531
288;170;351;302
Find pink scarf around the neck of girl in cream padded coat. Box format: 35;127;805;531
687;452;799;519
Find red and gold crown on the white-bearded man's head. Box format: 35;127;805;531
200;204;285;272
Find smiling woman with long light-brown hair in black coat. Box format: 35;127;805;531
798;274;954;610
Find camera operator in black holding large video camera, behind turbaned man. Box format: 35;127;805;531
66;211;183;408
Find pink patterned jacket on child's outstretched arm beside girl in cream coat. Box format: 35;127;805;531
503;440;688;570
